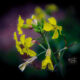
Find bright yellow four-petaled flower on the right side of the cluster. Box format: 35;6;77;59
43;17;62;39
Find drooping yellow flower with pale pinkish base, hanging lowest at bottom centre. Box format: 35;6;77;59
42;49;54;71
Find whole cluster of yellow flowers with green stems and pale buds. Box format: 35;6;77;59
14;6;62;71
